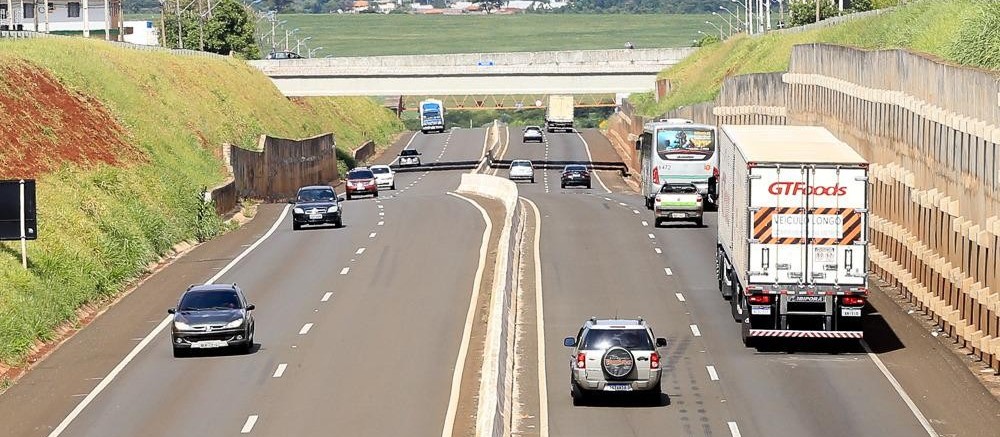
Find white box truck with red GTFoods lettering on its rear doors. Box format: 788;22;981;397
716;125;868;346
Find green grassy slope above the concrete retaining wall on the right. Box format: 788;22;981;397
631;0;1000;116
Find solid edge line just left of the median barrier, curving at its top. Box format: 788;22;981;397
441;191;493;437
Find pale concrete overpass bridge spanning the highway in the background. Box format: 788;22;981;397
250;48;694;97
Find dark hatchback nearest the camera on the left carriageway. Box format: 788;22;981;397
167;284;254;357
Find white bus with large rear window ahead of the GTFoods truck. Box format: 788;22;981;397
636;118;719;209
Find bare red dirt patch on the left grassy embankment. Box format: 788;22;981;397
0;61;136;179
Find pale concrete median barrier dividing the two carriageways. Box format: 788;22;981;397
456;174;523;437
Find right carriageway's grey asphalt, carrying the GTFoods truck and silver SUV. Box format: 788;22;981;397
501;127;927;437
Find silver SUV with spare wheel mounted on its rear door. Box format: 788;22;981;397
563;317;667;405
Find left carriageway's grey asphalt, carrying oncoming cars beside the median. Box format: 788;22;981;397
20;131;492;436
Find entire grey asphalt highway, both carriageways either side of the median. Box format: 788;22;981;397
0;128;996;437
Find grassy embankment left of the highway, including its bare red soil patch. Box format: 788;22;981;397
0;39;403;368
